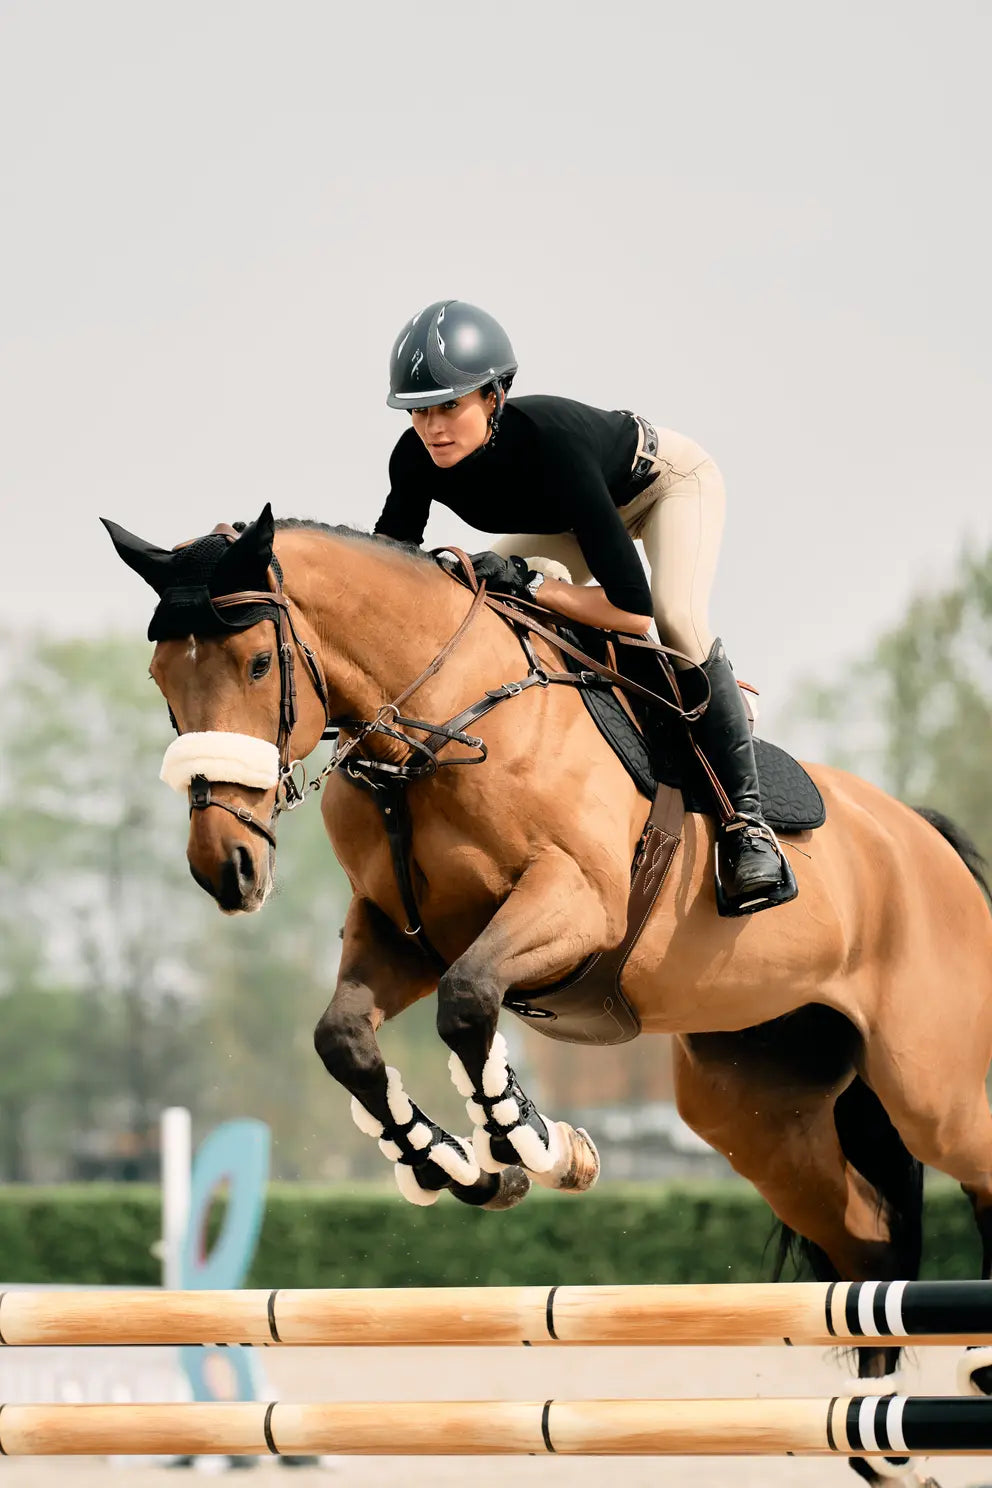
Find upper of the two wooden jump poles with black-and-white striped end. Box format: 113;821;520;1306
0;1281;992;1347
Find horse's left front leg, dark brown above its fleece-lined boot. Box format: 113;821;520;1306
314;897;529;1208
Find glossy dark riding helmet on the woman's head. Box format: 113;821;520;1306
387;299;516;409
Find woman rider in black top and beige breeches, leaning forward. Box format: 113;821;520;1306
375;299;796;914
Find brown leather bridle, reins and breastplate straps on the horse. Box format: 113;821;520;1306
190;541;718;967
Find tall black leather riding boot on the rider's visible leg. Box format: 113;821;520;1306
692;640;799;915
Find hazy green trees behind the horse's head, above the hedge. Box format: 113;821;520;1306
0;638;357;1178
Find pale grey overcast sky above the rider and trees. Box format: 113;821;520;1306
0;0;992;744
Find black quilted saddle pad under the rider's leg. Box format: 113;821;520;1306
564;631;827;833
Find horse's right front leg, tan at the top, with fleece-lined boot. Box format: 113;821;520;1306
437;851;615;1192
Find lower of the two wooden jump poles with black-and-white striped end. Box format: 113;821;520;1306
0;1396;992;1457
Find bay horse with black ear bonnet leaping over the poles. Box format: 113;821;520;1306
107;506;992;1481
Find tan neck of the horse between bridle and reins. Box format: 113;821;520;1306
277;530;467;719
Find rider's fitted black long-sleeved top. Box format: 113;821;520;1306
375;396;651;615
